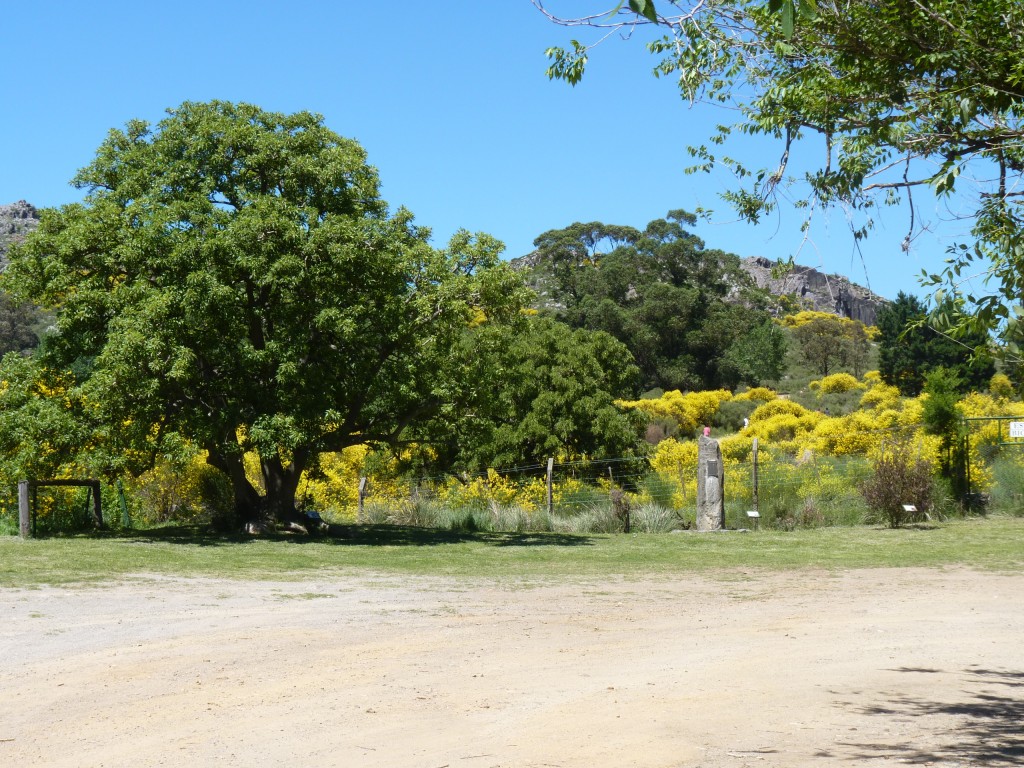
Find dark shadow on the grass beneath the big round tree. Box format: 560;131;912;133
84;524;594;547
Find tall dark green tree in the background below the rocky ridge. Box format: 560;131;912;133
529;211;770;390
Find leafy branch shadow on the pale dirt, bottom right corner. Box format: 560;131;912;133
821;667;1024;766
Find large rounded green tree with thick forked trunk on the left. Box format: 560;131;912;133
3;101;522;519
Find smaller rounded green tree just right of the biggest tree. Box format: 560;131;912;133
417;317;645;471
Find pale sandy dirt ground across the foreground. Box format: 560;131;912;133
0;569;1024;768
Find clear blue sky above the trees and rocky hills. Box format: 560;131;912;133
0;0;966;298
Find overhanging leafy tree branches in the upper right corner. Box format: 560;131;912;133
534;0;1024;335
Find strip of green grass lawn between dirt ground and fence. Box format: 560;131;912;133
0;516;1024;587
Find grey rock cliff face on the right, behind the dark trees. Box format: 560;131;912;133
742;256;889;326
